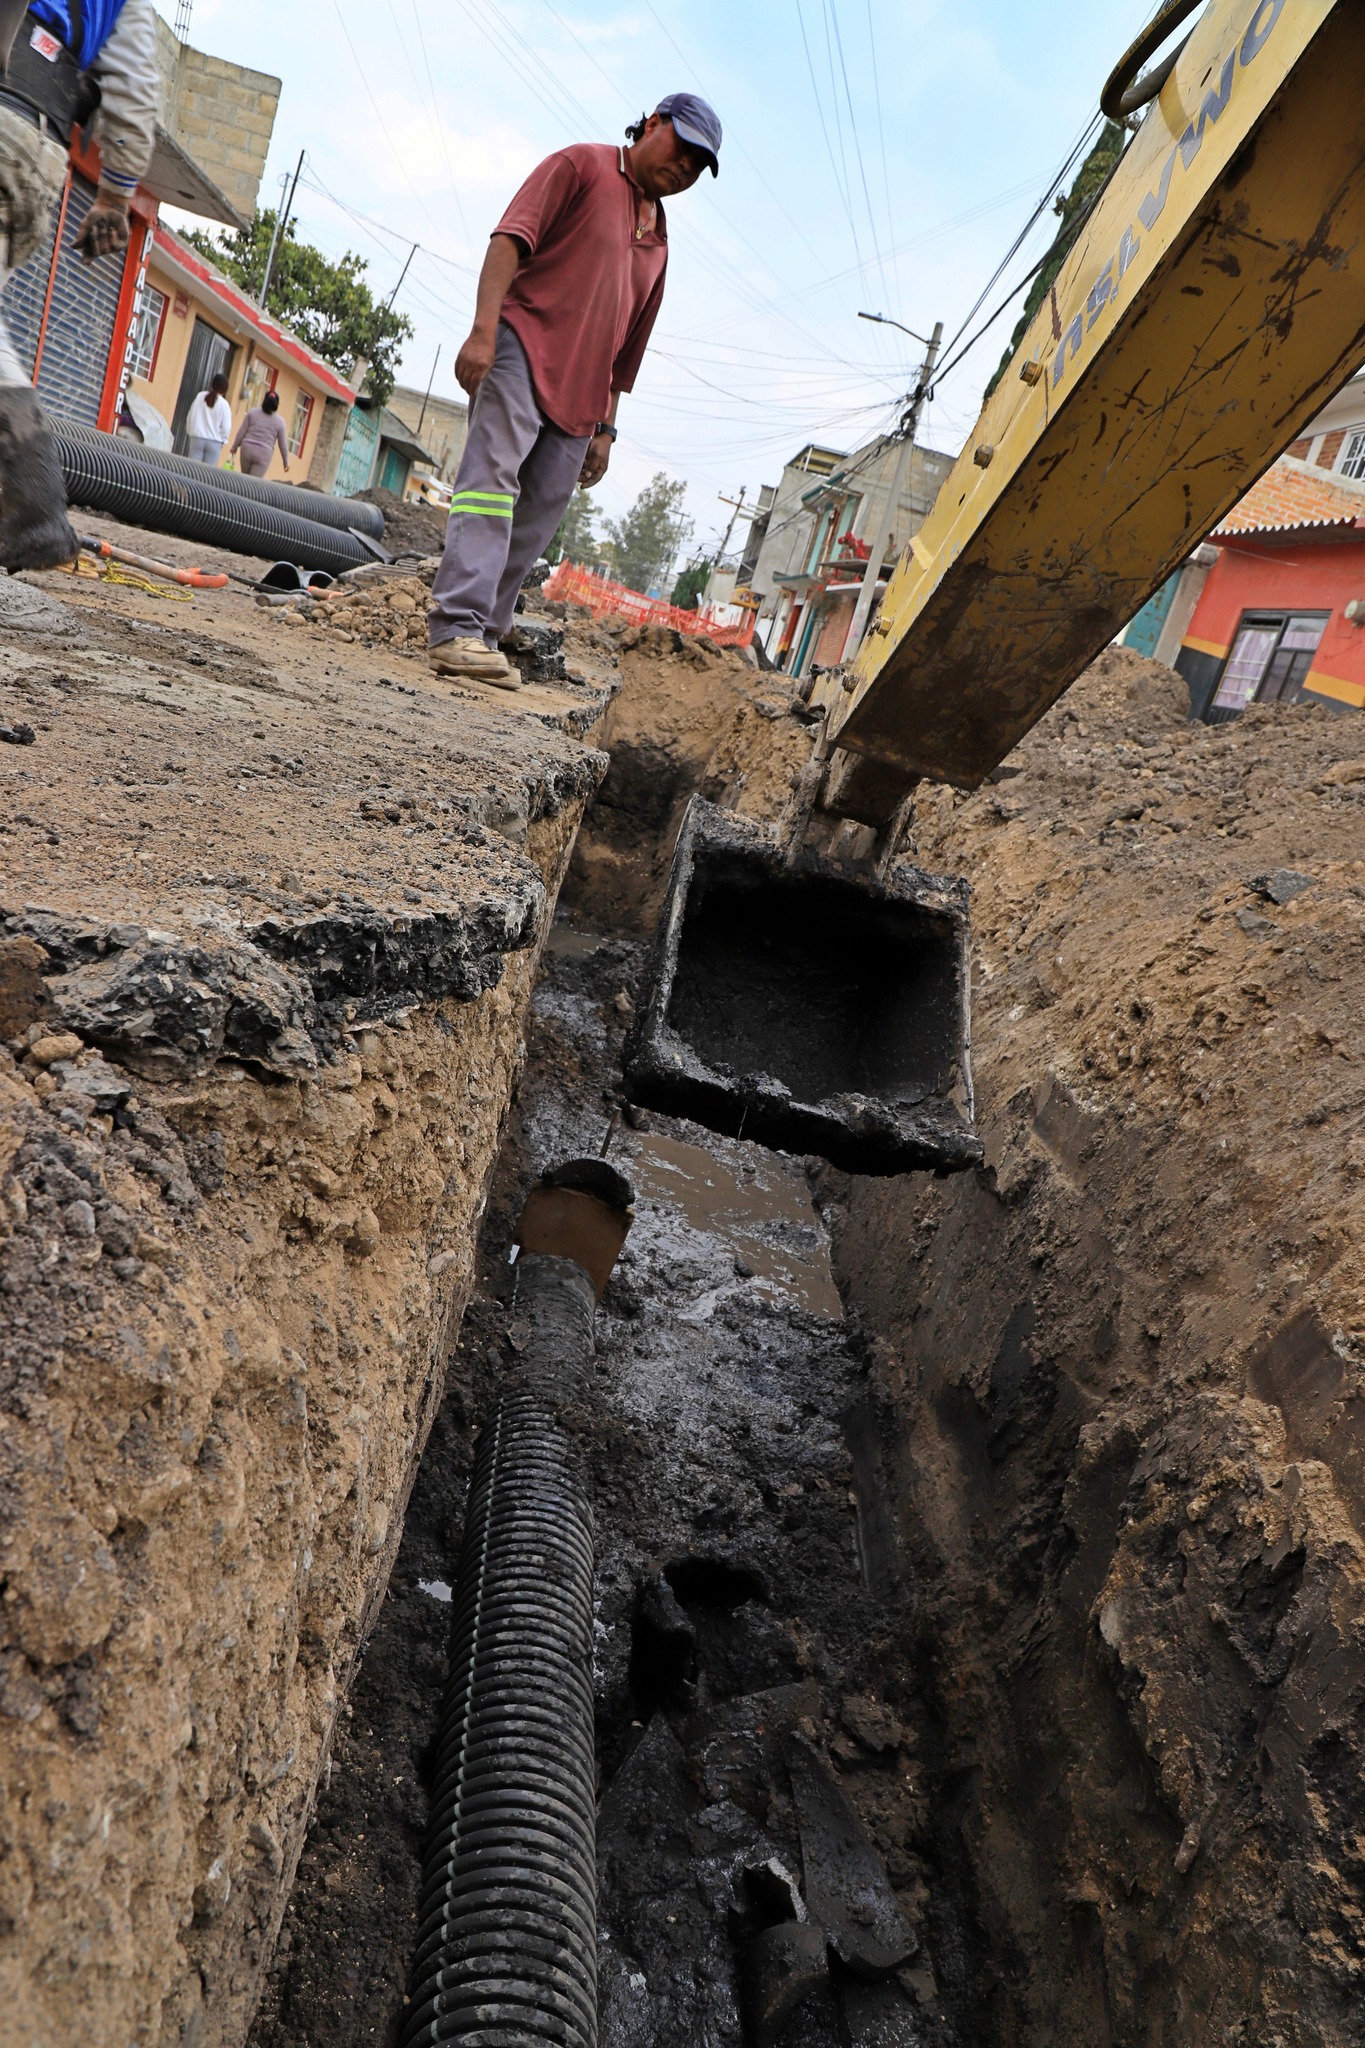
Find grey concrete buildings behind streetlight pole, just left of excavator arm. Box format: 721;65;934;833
733;436;954;676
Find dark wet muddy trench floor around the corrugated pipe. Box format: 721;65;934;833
252;924;968;2048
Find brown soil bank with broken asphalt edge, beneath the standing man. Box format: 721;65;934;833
0;565;606;2048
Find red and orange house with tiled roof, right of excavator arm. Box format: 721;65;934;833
1124;373;1365;723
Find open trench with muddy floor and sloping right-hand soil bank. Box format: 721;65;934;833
252;622;1365;2048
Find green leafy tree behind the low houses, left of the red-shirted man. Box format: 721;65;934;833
182;209;413;406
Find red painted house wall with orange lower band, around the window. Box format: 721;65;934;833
1185;535;1365;709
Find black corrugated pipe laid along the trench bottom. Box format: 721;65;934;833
401;1159;630;2048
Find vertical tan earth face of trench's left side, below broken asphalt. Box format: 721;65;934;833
0;774;604;2048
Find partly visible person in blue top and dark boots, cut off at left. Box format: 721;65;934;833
0;0;158;569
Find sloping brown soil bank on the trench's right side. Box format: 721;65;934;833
829;653;1365;2048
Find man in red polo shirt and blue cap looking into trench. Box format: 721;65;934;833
430;92;720;690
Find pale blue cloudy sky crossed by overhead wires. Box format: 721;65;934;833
158;0;1152;549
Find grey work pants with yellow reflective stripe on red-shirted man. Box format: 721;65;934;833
428;322;589;647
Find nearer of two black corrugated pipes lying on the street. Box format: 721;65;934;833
53;422;375;575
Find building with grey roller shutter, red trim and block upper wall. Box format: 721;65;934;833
4;20;280;452
